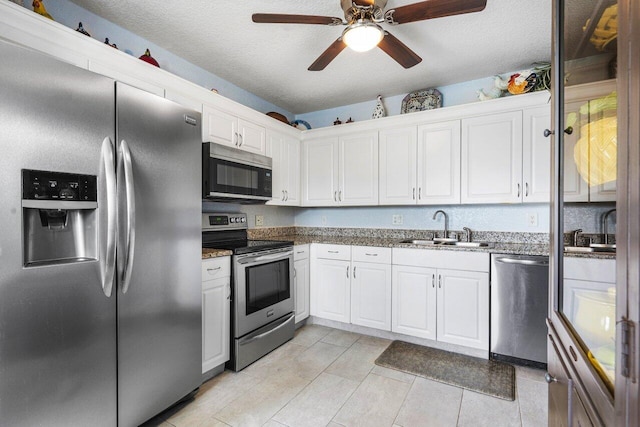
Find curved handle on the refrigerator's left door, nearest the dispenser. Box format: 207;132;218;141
100;137;118;297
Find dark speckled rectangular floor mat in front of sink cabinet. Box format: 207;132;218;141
376;341;515;400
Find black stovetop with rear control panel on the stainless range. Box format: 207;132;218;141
202;213;293;255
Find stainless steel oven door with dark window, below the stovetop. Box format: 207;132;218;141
233;247;294;338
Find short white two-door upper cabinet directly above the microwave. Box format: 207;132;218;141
202;105;267;155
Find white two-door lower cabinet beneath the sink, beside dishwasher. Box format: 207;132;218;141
391;248;489;350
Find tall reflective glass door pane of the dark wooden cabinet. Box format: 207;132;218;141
552;0;618;402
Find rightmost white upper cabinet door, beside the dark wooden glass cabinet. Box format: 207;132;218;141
522;106;551;203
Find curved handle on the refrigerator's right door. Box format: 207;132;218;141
118;139;136;294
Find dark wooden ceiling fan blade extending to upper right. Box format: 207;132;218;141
385;0;487;24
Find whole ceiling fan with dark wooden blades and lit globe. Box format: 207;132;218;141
252;0;487;71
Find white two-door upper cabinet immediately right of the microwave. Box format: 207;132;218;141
267;129;300;206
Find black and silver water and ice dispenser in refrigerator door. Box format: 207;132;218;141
22;169;98;267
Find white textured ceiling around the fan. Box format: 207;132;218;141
67;0;551;114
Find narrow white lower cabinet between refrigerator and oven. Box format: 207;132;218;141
202;257;231;373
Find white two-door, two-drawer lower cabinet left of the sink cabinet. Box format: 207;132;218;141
311;244;391;331
